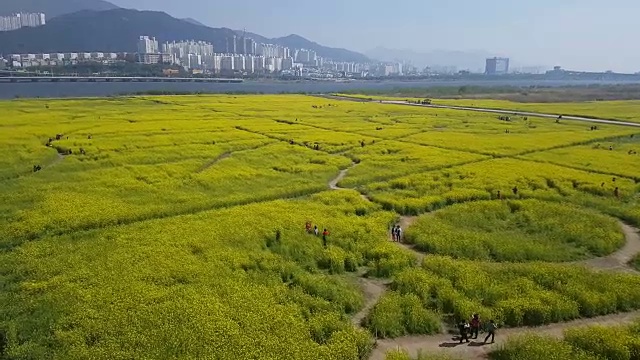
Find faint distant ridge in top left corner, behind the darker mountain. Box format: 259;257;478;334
0;0;118;19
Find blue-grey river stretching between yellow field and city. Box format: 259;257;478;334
0;80;640;99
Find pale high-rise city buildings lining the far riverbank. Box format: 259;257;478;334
1;32;520;79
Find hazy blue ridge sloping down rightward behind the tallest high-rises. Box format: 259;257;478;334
241;31;369;62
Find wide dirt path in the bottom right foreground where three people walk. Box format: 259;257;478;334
369;311;640;360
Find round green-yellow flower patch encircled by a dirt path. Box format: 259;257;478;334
407;200;624;262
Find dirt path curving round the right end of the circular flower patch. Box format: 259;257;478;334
576;222;640;273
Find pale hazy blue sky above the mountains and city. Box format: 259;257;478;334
111;0;640;72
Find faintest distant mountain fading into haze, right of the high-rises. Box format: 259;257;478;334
366;47;495;71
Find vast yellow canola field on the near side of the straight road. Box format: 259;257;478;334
0;95;640;360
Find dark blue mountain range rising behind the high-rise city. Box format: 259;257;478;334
0;0;369;62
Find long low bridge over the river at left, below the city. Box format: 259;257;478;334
0;76;244;84
